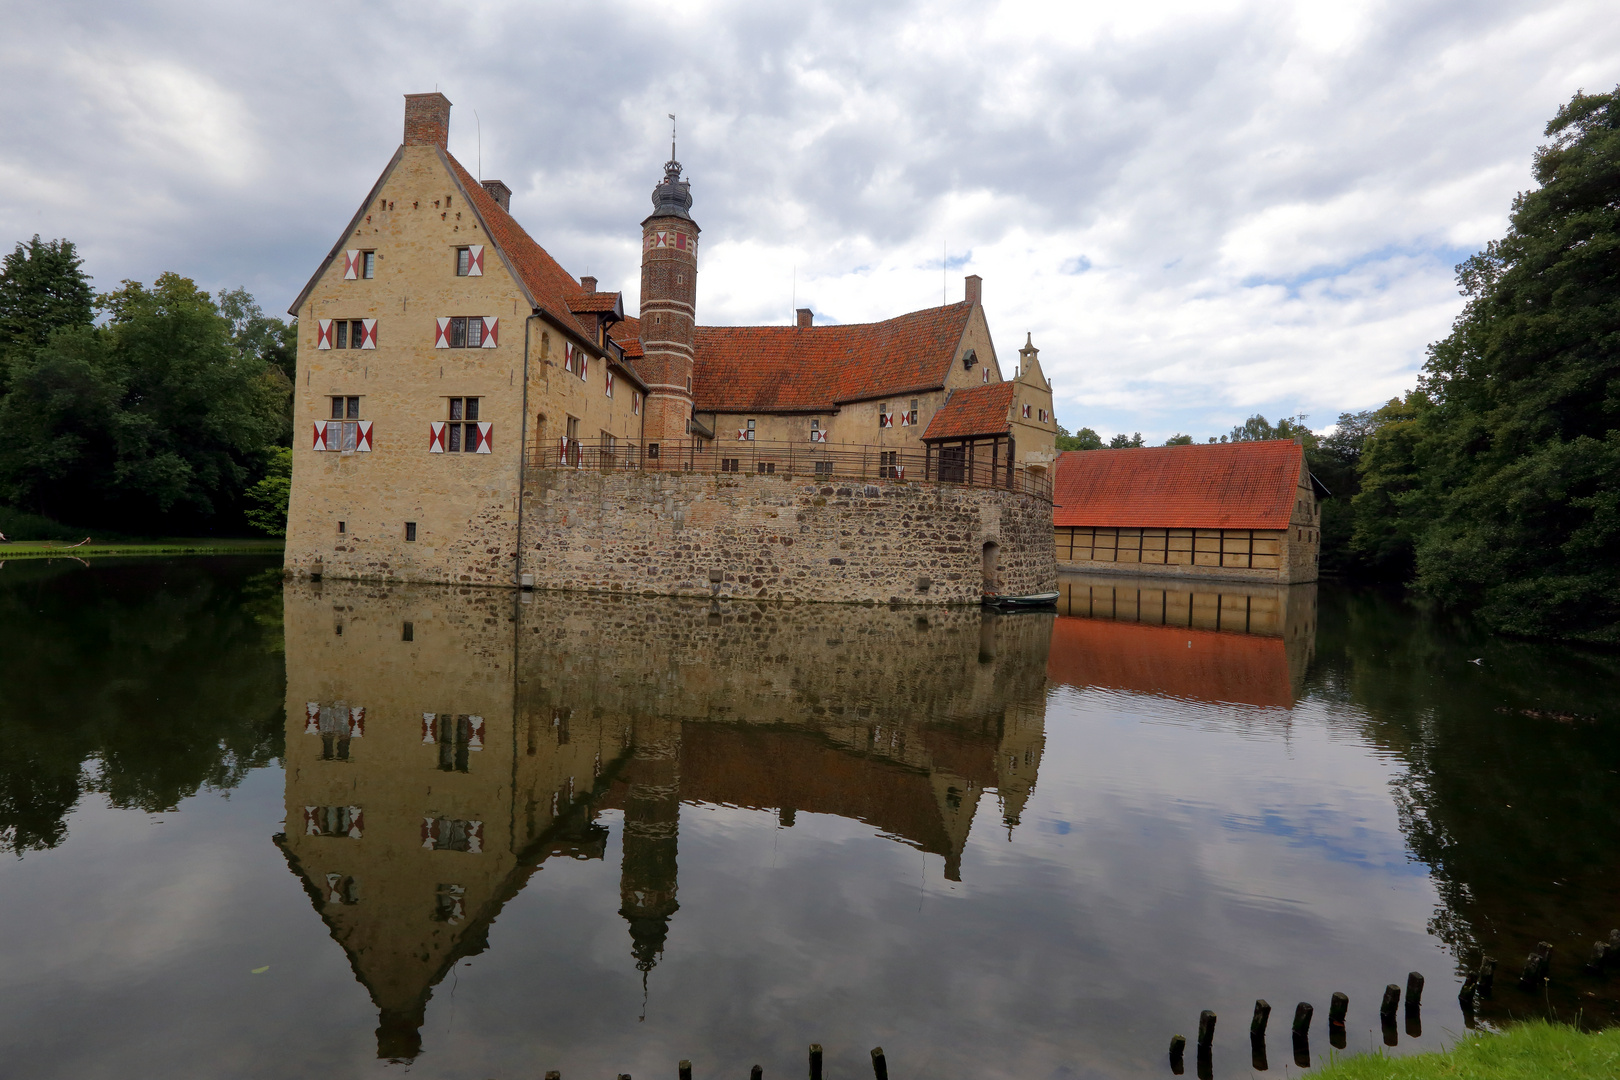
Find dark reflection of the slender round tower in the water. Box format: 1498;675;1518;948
619;721;680;984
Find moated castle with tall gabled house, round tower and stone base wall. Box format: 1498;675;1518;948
287;94;1056;602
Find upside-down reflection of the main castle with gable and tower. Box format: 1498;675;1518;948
277;583;1053;1059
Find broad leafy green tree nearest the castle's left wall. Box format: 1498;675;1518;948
0;274;290;531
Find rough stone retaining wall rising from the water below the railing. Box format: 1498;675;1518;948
520;470;1056;604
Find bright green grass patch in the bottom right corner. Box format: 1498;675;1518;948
1315;1020;1620;1080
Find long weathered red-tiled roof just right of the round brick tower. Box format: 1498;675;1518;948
692;301;974;413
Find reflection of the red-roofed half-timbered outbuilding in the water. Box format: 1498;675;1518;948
1048;573;1317;708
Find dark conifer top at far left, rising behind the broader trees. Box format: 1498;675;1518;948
0;233;96;395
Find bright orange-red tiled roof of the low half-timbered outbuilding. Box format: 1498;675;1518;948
1051;439;1304;529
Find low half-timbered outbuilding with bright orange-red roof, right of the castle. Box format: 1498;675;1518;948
1051;439;1328;581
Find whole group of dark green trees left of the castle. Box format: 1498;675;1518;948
0;235;296;539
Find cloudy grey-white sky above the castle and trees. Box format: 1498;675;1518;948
0;0;1620;440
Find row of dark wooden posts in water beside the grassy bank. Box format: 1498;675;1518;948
1172;929;1620;1080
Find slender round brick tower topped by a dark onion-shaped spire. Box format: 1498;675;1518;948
638;153;698;444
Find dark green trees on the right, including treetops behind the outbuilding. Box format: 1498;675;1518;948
1059;87;1620;644
